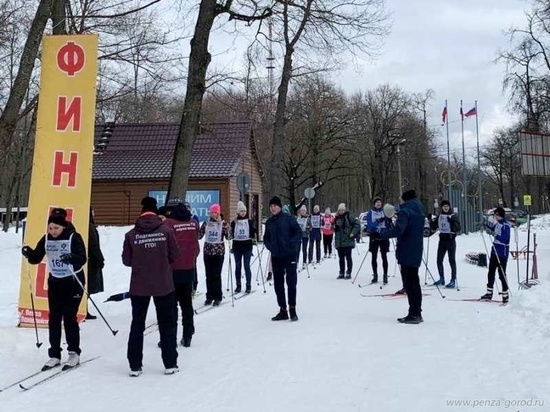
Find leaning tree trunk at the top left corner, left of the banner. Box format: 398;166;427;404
0;0;54;167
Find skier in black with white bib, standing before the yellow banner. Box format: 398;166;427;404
21;208;86;370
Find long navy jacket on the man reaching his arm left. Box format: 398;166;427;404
380;198;425;267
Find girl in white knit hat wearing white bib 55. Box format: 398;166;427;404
231;202;256;293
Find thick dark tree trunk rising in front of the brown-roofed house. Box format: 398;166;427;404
166;0;217;201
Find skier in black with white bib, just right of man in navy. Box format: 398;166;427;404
428;200;460;289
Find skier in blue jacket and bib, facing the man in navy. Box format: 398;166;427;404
367;197;391;285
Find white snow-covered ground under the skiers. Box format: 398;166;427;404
0;217;550;412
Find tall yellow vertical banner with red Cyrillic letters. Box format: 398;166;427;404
19;35;98;326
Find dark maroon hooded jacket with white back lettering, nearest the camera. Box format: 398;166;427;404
122;212;180;296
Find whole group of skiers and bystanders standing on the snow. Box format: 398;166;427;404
18;190;510;376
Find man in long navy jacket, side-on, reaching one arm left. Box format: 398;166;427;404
370;190;425;324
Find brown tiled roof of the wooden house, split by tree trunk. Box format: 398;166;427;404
92;122;252;179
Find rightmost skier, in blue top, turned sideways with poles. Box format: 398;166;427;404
480;207;510;303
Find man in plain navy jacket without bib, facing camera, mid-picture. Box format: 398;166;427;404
264;196;302;321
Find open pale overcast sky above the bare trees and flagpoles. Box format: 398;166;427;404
179;0;529;160
